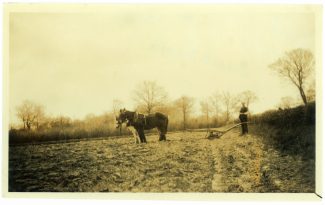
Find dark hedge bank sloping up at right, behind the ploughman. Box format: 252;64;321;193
251;102;316;158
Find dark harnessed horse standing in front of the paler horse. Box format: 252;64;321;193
116;108;168;143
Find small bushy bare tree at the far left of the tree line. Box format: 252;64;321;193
17;100;44;130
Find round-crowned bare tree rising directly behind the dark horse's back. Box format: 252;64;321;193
133;81;167;114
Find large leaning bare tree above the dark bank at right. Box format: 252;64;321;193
269;48;315;106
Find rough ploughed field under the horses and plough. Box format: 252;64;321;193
9;129;315;192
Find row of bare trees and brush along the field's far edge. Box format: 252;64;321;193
16;86;257;130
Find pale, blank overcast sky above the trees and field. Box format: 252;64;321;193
9;5;315;122
